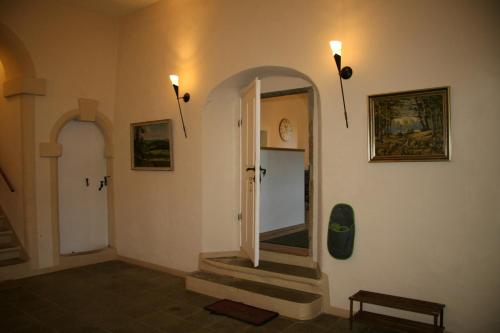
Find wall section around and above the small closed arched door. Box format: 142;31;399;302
0;0;118;267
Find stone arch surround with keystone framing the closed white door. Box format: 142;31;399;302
40;98;115;265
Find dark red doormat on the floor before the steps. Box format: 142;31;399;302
205;299;279;326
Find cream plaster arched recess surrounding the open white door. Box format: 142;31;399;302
201;66;321;261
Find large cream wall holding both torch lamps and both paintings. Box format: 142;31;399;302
115;0;500;331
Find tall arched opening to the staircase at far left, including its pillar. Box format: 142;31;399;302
0;24;45;267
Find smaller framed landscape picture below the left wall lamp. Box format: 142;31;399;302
130;119;174;170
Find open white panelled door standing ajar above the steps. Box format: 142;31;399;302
240;79;260;267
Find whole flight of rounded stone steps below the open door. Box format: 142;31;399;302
186;251;329;320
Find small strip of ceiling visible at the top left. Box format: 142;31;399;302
62;0;159;16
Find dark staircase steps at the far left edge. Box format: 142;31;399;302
0;210;27;267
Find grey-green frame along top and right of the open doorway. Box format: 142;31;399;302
259;86;318;258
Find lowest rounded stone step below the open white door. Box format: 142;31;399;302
186;271;323;320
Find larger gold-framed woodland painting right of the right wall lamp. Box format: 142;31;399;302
368;87;450;162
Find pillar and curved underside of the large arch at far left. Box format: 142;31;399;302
0;23;46;268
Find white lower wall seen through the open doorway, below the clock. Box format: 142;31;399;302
260;149;305;233
